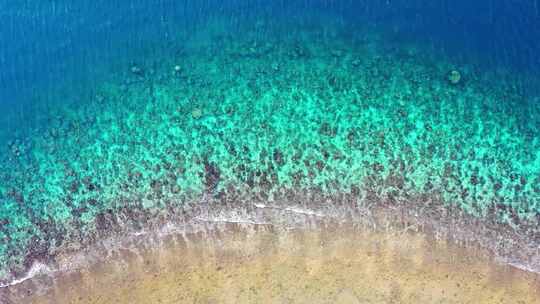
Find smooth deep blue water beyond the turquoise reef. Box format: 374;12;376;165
0;0;540;109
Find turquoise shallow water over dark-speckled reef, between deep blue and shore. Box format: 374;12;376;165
0;8;540;282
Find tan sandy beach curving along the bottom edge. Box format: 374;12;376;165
17;224;540;304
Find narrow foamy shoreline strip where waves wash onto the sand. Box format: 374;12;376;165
0;196;540;303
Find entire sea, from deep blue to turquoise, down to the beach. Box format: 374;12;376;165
0;0;540;299
